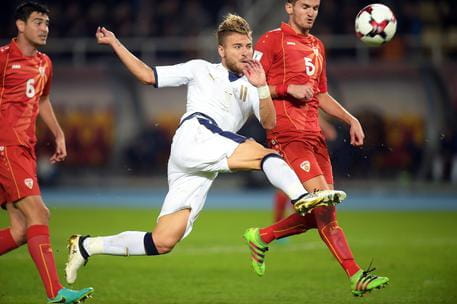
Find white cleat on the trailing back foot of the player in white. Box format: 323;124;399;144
65;234;89;284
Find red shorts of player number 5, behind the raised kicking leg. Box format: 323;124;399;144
269;133;333;184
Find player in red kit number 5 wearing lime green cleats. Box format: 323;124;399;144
244;0;389;296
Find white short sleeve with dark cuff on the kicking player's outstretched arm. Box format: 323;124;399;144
154;60;206;88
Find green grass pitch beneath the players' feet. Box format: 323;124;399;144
0;208;457;304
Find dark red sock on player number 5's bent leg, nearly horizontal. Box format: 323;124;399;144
259;213;316;244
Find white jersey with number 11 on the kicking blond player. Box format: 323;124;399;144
154;60;260;132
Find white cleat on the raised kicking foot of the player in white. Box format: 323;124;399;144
292;190;346;216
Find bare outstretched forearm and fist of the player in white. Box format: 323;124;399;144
95;27;156;85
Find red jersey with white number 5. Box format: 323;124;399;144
254;23;327;138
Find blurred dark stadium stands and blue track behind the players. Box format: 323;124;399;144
0;0;457;209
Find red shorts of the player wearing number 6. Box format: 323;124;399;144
0;146;41;206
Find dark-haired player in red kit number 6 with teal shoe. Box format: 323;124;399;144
0;2;93;303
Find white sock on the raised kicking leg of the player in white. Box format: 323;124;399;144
261;154;308;200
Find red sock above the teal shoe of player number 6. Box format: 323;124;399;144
27;225;63;299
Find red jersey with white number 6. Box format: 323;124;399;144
0;39;52;151
